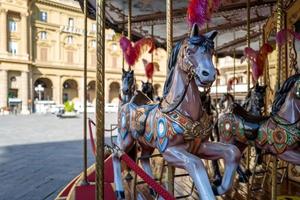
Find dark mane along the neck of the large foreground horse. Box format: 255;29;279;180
163;41;183;97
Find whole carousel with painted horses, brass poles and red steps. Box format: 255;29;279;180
56;0;300;200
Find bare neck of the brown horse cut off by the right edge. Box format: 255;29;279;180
277;94;300;123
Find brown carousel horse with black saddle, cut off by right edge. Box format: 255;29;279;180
218;74;300;178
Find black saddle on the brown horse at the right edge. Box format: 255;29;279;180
231;103;269;140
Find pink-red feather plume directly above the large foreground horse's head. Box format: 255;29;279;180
187;0;221;27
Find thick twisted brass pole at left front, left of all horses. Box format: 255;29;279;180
96;0;105;200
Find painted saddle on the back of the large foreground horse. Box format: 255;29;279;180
129;90;158;136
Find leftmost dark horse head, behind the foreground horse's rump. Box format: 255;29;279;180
122;69;135;95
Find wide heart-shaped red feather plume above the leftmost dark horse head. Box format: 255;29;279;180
120;36;156;66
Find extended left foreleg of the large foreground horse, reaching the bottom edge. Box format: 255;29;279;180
162;145;216;200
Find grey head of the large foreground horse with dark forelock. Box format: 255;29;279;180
180;24;217;87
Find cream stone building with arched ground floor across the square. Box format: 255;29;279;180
0;0;167;114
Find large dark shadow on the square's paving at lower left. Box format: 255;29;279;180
0;138;108;200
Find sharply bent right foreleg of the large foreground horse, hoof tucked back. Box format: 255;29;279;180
197;142;241;195
